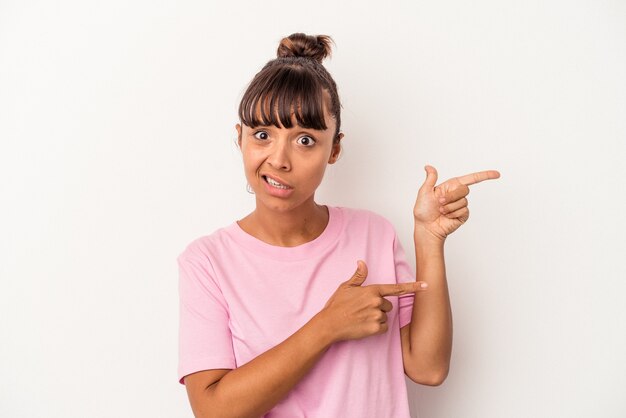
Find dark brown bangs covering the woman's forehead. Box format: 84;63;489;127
239;66;327;130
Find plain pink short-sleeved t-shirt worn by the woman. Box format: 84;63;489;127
178;207;415;418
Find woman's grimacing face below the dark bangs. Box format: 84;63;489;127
236;102;343;212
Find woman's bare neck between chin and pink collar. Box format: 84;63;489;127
237;201;329;247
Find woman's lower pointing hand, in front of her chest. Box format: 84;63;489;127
320;260;428;342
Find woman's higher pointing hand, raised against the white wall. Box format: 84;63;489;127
413;165;500;241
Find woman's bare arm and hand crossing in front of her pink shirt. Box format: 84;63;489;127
185;261;421;418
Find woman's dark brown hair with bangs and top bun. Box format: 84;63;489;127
239;33;341;141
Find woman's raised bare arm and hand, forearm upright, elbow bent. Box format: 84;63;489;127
400;166;500;386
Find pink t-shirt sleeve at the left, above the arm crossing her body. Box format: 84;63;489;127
177;251;236;384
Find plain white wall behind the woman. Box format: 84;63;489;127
0;0;626;418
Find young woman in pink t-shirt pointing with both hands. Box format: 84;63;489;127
178;34;499;418
